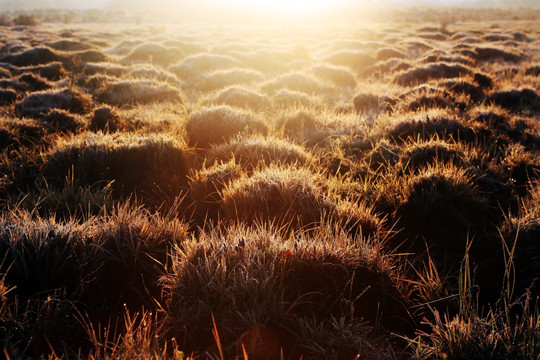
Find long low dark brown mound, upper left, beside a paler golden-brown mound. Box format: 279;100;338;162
17;89;92;117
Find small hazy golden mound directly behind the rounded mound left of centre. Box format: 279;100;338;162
208;86;270;110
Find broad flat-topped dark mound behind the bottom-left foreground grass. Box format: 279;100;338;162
44;133;190;203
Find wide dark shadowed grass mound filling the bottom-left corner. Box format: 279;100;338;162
0;204;190;357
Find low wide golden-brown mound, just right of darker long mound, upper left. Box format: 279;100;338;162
97;80;182;105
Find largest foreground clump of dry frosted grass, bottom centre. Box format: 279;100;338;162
162;227;408;358
